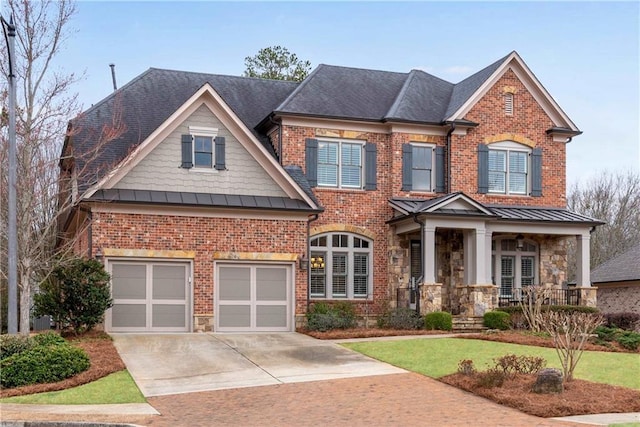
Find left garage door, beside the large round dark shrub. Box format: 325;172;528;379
107;261;190;332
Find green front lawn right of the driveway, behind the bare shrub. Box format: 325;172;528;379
342;338;640;390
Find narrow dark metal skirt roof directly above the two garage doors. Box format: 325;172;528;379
90;189;318;212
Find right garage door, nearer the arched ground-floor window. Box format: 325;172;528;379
216;264;293;332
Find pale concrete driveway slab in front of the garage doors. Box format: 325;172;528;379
112;332;406;397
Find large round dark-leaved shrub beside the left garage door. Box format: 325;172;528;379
33;258;113;333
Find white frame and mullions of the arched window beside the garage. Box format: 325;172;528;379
309;232;373;301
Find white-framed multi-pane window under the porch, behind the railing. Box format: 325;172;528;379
491;237;538;297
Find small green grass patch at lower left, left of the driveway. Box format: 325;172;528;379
0;370;147;405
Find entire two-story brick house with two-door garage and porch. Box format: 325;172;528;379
61;52;600;331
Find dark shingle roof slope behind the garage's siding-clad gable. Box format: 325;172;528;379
72;68;297;189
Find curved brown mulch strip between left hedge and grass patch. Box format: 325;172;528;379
0;331;125;398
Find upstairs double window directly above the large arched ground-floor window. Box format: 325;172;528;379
318;140;364;188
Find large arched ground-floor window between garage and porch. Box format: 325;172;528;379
309;233;373;299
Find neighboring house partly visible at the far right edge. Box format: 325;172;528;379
591;244;640;314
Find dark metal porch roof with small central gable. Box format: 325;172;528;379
389;192;604;226
